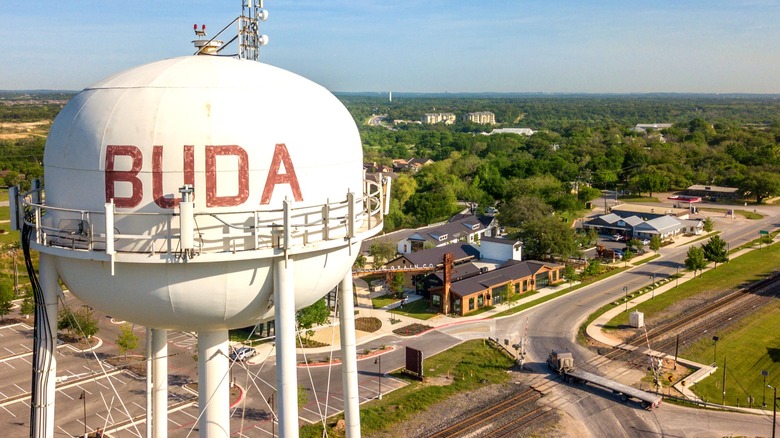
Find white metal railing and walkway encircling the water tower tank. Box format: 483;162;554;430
22;181;385;256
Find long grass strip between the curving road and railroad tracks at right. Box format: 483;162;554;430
604;244;780;329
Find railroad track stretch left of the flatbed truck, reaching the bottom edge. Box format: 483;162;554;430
429;389;542;438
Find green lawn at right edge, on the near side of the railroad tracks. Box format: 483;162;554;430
682;300;780;410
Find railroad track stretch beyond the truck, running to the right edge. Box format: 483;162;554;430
602;275;780;368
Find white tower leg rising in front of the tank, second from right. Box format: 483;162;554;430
274;257;298;438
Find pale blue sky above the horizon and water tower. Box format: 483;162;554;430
0;0;780;93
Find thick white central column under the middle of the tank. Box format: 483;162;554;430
198;330;230;438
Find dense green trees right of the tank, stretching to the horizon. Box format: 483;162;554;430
346;96;780;257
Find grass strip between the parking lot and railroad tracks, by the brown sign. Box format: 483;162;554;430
300;340;514;438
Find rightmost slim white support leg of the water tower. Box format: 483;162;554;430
339;271;360;438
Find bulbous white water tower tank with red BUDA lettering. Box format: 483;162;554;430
36;56;381;330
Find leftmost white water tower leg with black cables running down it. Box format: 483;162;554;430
30;254;59;438
